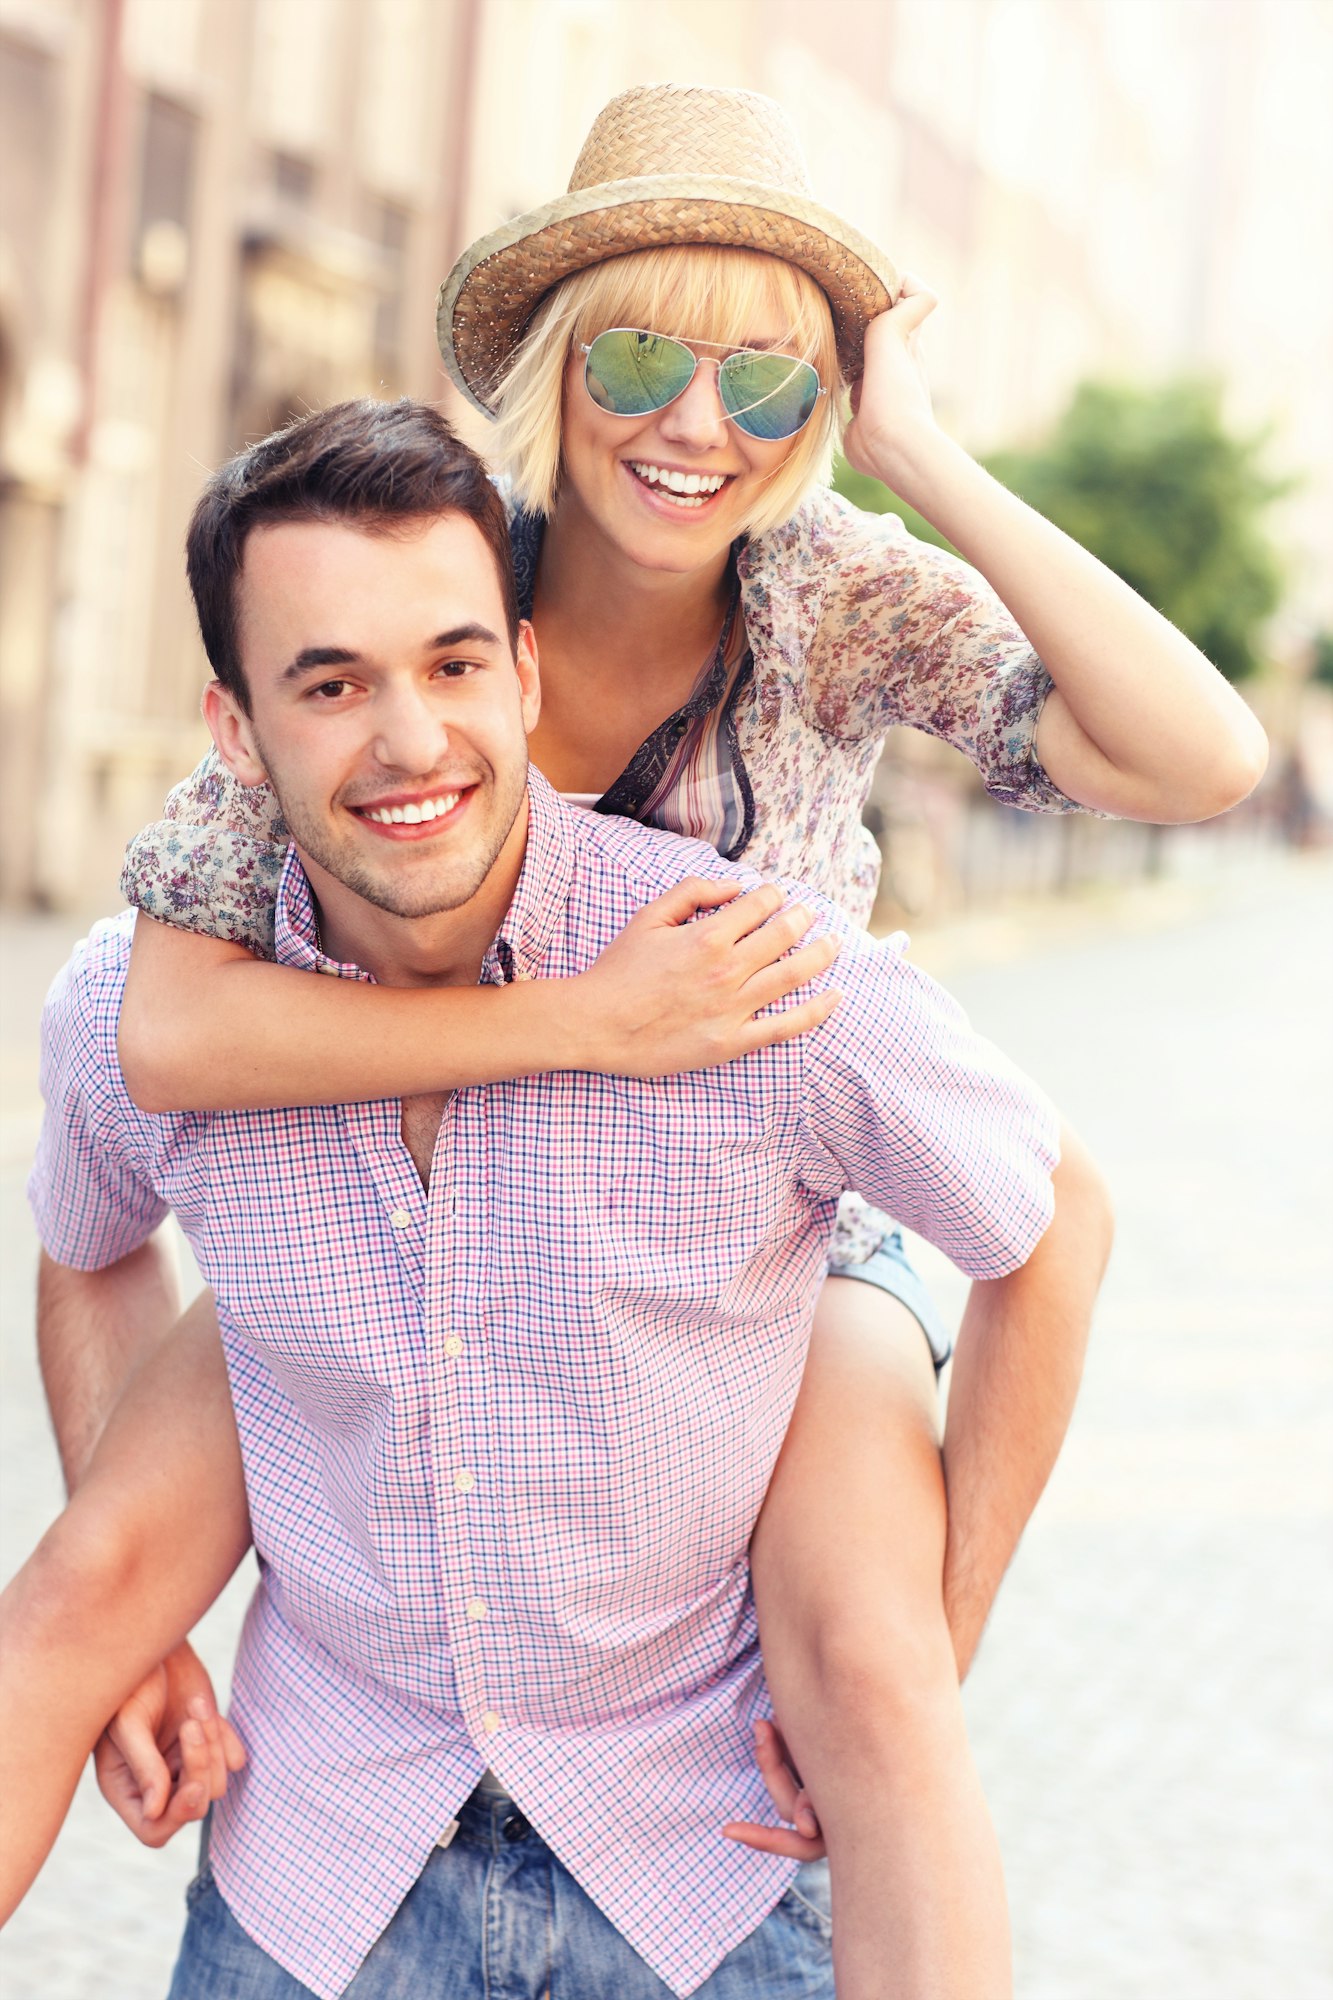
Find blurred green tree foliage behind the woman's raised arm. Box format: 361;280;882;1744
835;380;1291;680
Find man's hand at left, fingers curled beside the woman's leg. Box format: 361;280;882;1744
94;1640;246;1848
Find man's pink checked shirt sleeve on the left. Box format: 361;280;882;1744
28;926;166;1270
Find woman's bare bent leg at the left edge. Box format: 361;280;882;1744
0;1296;250;1922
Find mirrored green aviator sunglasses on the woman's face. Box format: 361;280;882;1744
580;326;829;440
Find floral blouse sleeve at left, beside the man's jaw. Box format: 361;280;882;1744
120;750;288;958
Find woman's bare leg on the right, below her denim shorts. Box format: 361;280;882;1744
753;1278;1013;2000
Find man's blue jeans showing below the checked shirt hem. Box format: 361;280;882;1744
170;1792;833;2000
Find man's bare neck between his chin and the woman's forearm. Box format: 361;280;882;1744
298;798;528;986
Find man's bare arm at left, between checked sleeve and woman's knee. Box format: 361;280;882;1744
38;1230;180;1492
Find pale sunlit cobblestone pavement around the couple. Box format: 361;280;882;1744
0;862;1333;2000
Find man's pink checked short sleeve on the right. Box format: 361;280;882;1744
788;932;1059;1278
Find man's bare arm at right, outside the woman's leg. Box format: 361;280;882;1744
932;1130;1111;1674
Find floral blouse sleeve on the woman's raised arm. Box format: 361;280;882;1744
784;492;1085;812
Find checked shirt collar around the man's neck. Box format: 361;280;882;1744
274;768;574;986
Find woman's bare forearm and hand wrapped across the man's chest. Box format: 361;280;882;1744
120;878;839;1112
